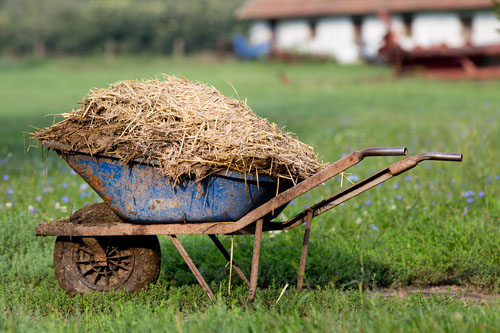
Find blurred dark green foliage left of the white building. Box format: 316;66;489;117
0;0;241;55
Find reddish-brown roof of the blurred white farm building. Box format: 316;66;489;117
236;0;494;20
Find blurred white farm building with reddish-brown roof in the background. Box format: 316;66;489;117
237;0;500;63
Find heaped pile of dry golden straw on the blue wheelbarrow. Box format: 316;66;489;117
31;76;321;181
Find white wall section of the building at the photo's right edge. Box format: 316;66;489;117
471;12;500;46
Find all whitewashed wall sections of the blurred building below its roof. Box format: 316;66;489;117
246;11;500;63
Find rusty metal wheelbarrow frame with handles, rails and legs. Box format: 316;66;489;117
36;147;462;303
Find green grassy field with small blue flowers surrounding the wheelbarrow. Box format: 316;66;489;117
0;58;500;332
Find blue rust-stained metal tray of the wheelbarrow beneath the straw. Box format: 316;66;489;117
57;150;293;223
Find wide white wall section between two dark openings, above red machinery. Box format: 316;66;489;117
411;13;465;48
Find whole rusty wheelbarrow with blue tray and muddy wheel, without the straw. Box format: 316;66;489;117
36;142;462;302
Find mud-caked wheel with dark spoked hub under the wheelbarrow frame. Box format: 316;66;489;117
54;236;161;296
